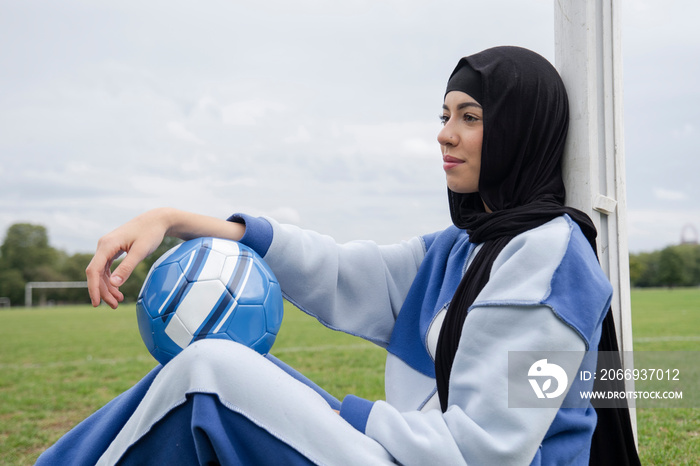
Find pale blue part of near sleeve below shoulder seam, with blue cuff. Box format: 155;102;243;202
341;306;585;465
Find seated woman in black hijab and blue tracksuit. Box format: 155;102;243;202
40;47;640;465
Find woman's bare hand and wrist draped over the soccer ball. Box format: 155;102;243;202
85;208;245;309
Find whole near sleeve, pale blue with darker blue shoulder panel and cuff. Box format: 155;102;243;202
341;217;610;465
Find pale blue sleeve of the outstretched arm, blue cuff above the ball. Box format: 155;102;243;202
229;214;425;347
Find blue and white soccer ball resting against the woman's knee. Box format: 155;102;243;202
136;238;283;364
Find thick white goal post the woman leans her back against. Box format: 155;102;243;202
553;0;636;435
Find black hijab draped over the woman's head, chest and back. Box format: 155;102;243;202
435;47;639;464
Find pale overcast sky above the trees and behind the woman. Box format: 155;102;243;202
0;0;700;253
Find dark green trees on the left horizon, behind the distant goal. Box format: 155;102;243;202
0;223;179;306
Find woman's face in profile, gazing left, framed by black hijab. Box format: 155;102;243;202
438;91;484;194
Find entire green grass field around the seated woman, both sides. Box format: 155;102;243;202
0;289;700;465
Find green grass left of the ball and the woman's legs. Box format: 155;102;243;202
0;306;153;464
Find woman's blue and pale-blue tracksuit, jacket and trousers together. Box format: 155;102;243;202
39;215;612;465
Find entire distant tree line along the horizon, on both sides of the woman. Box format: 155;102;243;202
0;223;700;306
